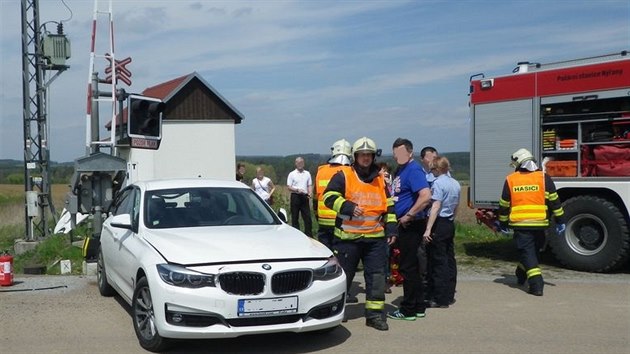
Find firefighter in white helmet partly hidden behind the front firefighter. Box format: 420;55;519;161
313;139;352;250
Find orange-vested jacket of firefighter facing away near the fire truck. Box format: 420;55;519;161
499;170;564;228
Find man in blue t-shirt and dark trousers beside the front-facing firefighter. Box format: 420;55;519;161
387;138;431;321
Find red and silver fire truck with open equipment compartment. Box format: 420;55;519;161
469;51;630;272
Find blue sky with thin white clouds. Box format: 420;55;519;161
0;0;630;162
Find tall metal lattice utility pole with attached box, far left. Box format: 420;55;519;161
22;0;70;241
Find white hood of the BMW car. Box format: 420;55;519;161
144;224;332;264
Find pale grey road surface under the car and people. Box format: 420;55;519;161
0;270;630;354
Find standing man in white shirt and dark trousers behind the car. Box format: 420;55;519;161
287;157;313;237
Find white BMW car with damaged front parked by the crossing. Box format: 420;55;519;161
97;179;346;351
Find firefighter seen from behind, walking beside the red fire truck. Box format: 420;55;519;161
498;149;565;296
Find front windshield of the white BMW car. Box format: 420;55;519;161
144;188;281;229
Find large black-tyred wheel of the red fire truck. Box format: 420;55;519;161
548;196;630;272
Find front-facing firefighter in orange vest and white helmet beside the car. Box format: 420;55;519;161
324;137;397;331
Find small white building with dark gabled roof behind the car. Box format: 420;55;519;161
108;72;244;182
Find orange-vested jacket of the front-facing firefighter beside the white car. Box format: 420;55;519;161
324;166;397;240
